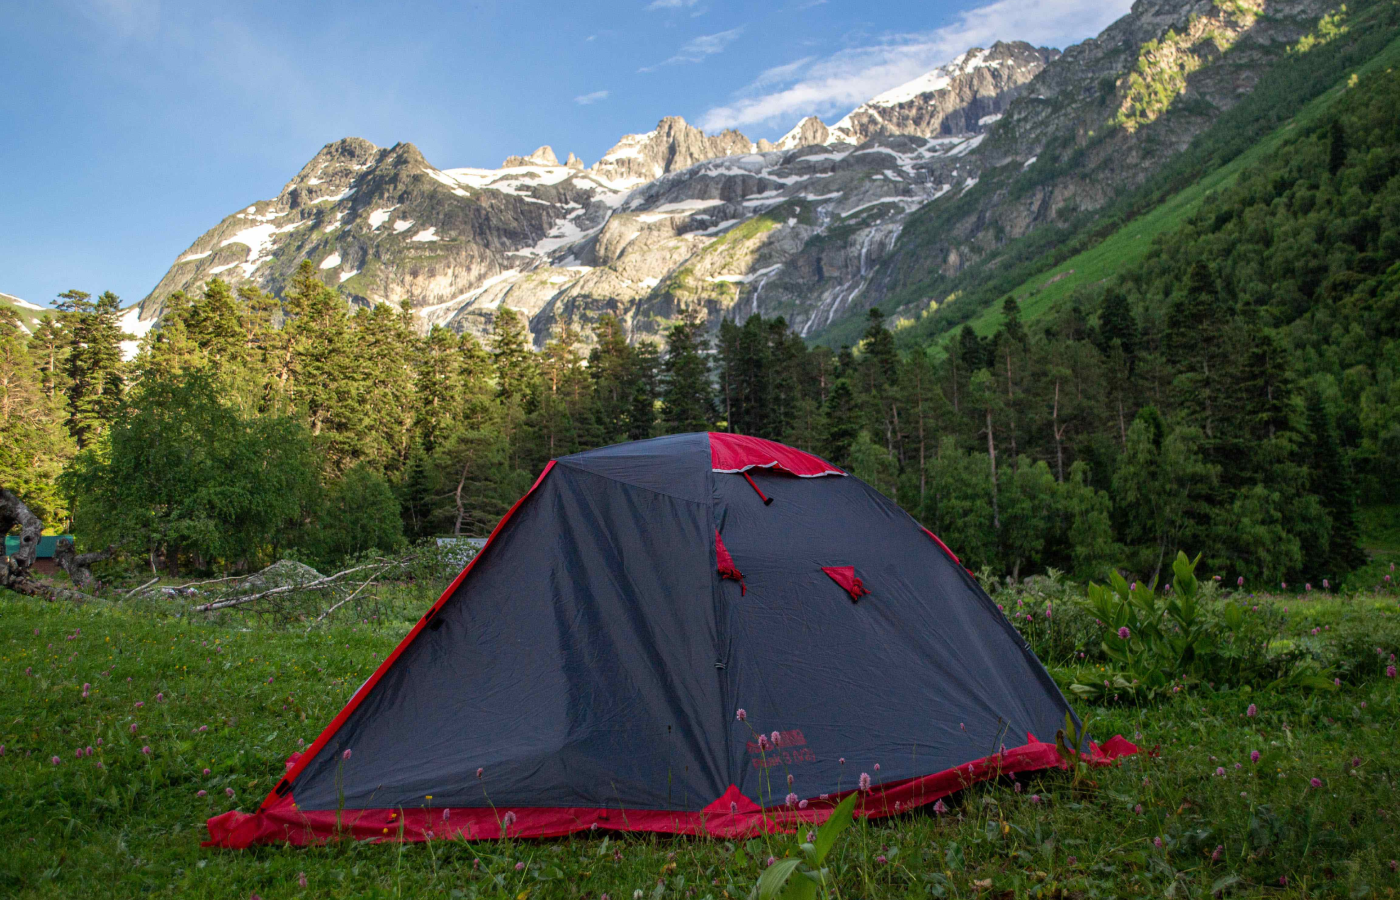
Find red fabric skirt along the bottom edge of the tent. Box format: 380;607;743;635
204;735;1137;850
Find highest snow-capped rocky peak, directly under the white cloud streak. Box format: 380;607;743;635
828;41;1060;144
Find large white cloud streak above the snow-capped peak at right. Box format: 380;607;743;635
700;0;1131;130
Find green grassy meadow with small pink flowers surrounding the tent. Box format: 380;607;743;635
0;589;1400;900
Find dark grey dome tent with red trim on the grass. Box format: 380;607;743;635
209;433;1135;847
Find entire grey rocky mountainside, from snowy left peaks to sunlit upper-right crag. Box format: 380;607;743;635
136;0;1327;346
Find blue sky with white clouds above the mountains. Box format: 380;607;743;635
0;0;1130;305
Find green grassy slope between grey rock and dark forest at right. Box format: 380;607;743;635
815;0;1400;350
